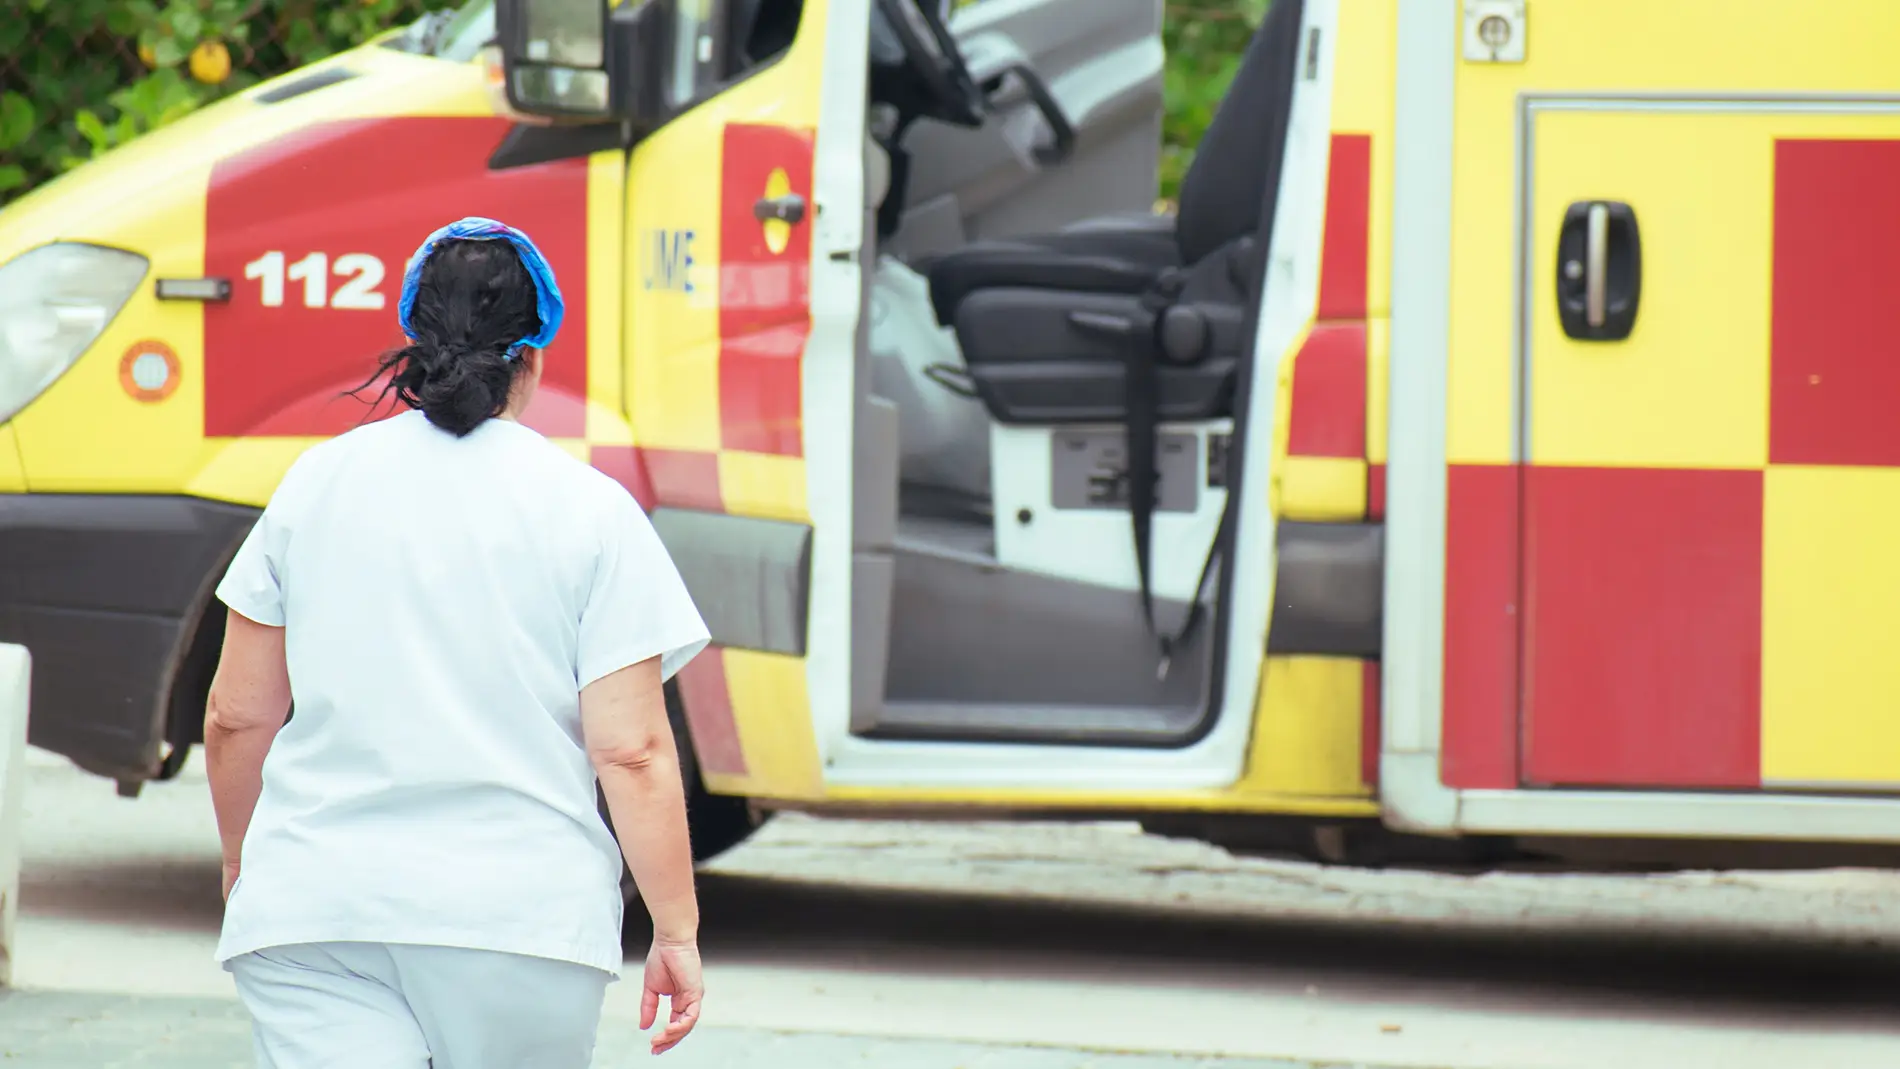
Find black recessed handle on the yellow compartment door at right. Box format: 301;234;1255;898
1556;201;1642;342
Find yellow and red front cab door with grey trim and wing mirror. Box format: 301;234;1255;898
498;0;872;808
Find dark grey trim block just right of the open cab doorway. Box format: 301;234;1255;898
1267;520;1385;659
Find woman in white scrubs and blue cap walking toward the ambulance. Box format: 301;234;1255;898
205;218;707;1069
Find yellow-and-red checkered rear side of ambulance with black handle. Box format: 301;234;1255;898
1442;0;1900;797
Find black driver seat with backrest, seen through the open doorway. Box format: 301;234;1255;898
929;0;1302;423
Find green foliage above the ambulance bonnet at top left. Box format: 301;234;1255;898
0;0;448;203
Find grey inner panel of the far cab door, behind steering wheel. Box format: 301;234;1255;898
889;0;1167;258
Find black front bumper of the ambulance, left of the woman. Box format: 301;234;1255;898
0;494;258;782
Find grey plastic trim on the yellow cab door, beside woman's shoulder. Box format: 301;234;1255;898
652;509;811;657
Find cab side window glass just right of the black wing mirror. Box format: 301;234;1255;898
667;0;806;108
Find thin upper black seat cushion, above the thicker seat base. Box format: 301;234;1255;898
929;220;1180;325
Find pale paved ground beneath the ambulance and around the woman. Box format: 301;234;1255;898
11;761;1900;1069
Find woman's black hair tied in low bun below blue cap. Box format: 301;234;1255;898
353;239;542;439
